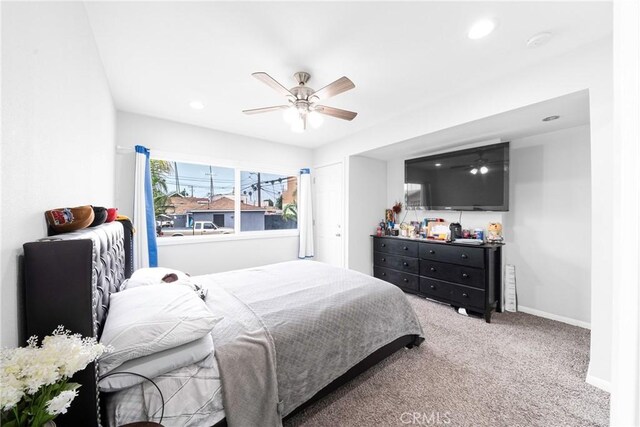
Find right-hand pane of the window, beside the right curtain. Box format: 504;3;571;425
240;171;298;231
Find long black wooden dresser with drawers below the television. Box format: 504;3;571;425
373;236;502;323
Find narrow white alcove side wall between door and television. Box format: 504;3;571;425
346;156;387;274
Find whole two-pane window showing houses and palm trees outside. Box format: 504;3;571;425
151;159;298;238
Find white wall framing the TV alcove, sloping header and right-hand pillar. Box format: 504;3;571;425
315;38;614;385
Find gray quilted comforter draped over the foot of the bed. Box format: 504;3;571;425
198;261;422;427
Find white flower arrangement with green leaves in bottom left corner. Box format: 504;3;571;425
0;326;110;427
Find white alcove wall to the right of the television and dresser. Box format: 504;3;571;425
504;126;592;326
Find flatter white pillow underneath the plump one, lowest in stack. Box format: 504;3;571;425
98;334;213;393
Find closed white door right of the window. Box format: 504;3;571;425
313;163;344;267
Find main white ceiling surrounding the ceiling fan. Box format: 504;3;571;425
86;1;611;147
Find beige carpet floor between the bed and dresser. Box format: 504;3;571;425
285;296;609;427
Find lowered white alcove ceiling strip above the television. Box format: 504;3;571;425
361;90;589;160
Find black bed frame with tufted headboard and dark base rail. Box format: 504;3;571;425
23;226;423;427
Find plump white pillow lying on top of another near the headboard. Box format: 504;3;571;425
99;286;222;375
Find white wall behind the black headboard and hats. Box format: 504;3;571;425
0;2;115;346
